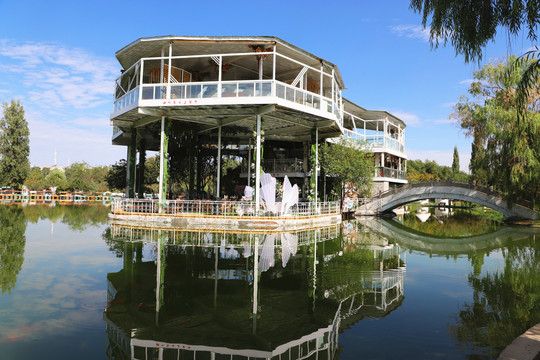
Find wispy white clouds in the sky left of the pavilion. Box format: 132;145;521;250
0;39;125;165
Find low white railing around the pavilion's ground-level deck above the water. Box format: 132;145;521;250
111;198;341;219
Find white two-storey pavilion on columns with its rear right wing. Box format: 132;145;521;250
111;36;406;224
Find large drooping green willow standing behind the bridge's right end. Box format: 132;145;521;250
452;56;540;207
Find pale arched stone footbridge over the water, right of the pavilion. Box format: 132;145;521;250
356;181;538;220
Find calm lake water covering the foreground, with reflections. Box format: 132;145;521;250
0;206;540;359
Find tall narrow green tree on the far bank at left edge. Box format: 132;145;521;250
0;100;30;189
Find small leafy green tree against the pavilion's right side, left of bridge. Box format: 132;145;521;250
319;139;375;200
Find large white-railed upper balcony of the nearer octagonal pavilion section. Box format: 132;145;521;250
111;44;343;128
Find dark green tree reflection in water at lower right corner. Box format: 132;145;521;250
450;235;540;355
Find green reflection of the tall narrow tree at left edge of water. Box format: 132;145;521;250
0;206;26;295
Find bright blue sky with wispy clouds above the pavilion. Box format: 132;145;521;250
0;0;536;171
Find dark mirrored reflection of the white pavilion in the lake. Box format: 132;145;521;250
104;224;405;359
